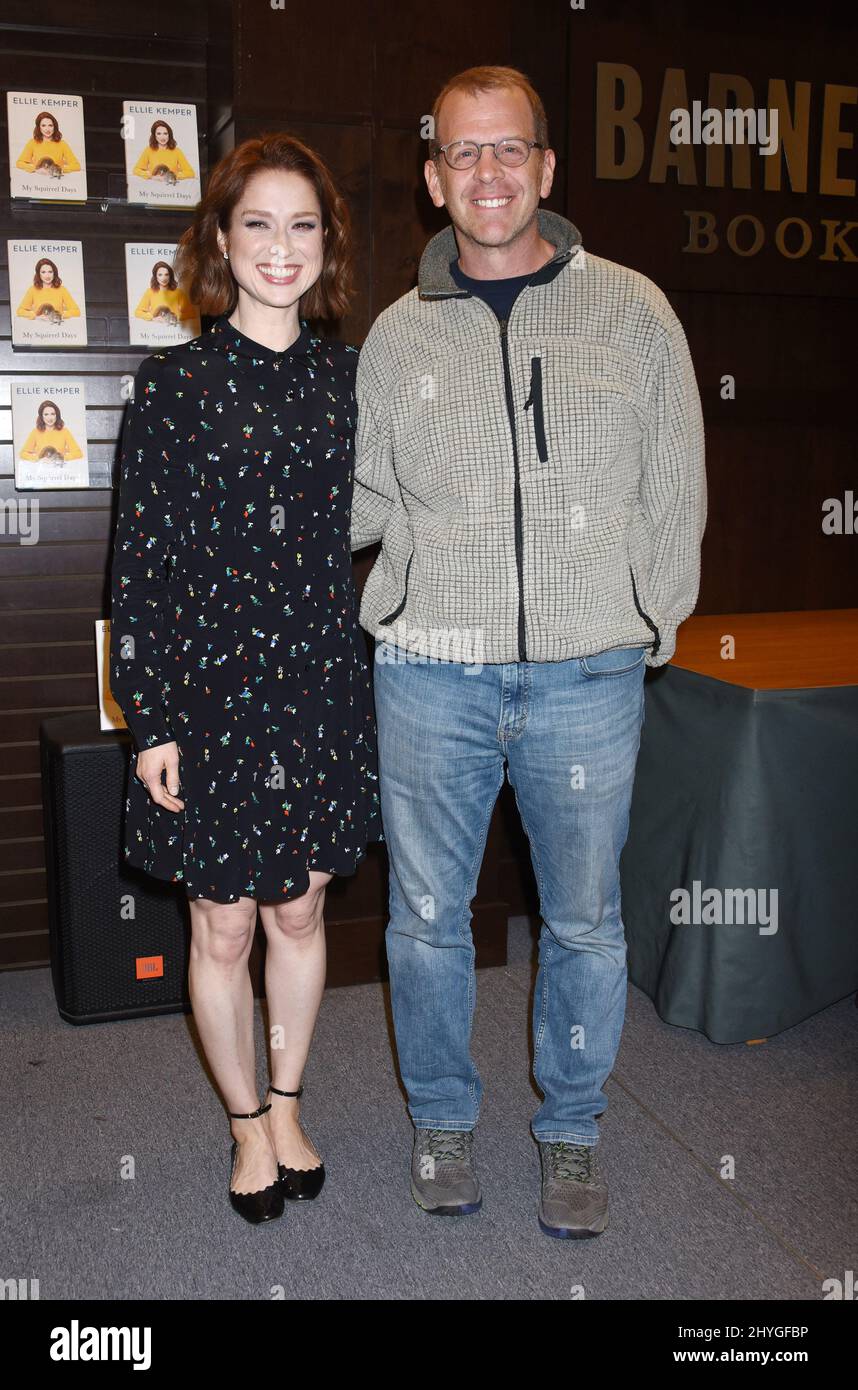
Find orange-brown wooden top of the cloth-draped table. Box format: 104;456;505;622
672;609;858;689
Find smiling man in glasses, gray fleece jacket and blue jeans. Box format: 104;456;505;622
352;68;706;1237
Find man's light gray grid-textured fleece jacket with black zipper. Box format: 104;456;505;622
352;209;706;666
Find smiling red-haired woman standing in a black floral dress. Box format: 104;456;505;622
111;135;382;1222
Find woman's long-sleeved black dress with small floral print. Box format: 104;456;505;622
110;316;382;902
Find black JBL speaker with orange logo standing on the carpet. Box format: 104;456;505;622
39;710;191;1023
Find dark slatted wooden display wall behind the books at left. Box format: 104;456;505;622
0;0;214;967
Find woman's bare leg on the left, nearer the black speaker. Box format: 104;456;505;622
188;898;277;1193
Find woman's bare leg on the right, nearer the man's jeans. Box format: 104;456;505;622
259;869;334;1168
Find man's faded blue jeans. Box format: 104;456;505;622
374;641;645;1144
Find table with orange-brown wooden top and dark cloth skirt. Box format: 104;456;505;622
620;609;858;1043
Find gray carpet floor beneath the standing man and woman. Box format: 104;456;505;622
0;919;858;1300
